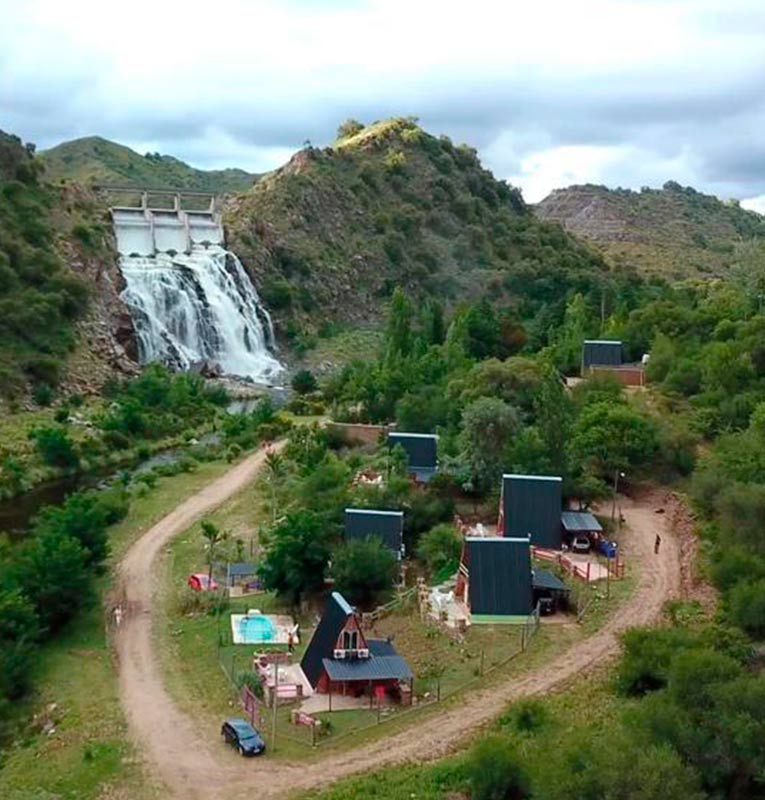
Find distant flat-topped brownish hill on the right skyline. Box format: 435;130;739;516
535;181;765;279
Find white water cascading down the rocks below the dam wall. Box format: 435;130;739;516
120;244;283;381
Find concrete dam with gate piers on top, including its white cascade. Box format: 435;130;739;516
111;192;283;383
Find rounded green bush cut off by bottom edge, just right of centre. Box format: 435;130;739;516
466;736;531;800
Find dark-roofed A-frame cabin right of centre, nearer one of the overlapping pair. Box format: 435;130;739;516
455;536;534;624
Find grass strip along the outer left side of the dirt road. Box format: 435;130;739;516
0;454;242;800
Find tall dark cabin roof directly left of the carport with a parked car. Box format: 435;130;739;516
497;475;563;550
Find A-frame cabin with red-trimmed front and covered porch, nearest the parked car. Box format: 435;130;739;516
300;592;414;701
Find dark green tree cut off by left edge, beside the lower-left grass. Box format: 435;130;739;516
0;589;39;700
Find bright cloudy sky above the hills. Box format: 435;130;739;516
0;0;765;211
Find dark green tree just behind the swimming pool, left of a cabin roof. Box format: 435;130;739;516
258;511;330;607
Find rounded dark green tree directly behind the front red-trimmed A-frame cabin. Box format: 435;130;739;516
332;536;399;608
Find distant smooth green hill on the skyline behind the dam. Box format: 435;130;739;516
41;136;257;192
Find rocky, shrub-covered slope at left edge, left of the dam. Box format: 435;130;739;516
0;131;133;402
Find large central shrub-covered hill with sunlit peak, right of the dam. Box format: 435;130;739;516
224;118;607;335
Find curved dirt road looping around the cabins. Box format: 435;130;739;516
115;460;681;800
